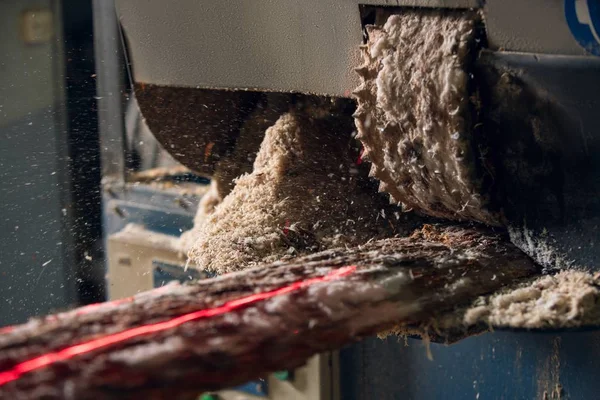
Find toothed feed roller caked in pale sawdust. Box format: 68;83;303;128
355;10;497;225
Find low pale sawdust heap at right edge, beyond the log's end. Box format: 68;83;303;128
464;270;600;329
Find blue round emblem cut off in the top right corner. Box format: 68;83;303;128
565;0;600;56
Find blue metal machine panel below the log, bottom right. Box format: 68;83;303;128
340;331;600;400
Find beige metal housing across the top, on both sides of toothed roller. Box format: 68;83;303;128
116;0;585;97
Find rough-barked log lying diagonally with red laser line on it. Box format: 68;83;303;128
0;226;538;399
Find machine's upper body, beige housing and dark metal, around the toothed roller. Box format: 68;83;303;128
117;0;600;268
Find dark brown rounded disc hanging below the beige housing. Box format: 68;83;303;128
134;83;261;177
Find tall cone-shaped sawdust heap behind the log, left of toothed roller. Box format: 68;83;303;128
188;110;400;273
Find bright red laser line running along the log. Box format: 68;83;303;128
0;265;356;386
